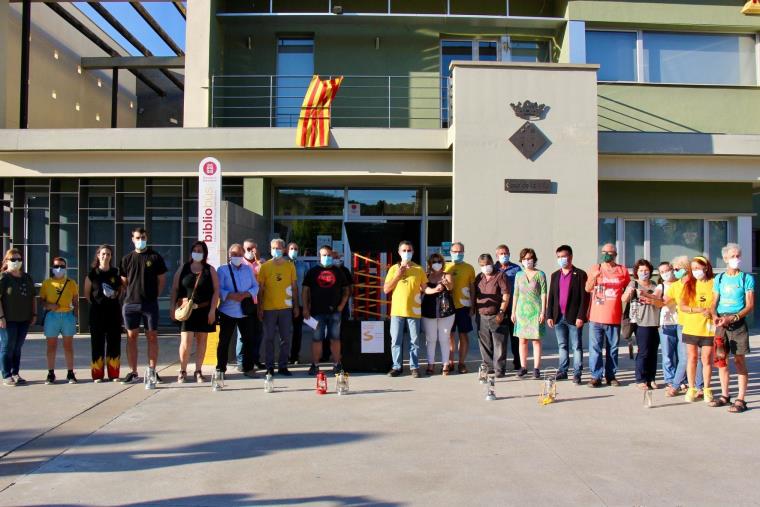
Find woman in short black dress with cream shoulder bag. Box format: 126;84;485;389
169;241;219;384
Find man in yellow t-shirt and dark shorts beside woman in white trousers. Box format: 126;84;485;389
445;241;475;373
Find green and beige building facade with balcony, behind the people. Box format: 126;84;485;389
0;0;760;326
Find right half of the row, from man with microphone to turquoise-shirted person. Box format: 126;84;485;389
383;241;755;412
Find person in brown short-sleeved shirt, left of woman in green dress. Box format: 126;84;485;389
473;253;512;378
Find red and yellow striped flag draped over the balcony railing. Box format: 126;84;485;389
296;75;343;148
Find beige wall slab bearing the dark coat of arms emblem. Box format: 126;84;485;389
453;64;598;272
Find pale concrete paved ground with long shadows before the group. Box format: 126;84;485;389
0;336;760;506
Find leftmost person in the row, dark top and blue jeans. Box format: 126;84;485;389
0;248;37;387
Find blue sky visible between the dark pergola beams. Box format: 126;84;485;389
73;2;185;56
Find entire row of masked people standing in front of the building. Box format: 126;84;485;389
0;232;755;412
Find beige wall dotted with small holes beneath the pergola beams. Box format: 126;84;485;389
0;0;137;128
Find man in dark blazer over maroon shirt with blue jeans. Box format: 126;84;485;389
546;245;590;385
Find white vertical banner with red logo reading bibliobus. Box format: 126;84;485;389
198;157;222;267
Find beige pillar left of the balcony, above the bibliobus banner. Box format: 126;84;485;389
183;0;213;127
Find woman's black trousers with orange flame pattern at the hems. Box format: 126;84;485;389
90;304;121;380
